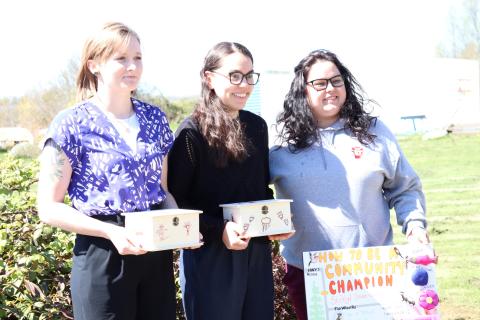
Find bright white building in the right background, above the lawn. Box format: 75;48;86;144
359;58;480;134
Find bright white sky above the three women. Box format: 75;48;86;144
0;0;461;98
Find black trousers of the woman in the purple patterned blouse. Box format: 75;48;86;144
71;217;176;320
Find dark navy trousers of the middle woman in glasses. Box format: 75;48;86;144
183;237;273;320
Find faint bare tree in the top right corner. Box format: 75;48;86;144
437;0;480;59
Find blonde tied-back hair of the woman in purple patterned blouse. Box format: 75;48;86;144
76;22;140;101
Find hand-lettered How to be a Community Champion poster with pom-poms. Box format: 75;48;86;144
303;245;440;320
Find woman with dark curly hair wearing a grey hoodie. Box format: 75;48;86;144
270;50;429;320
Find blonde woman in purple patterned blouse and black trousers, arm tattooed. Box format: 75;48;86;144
38;22;175;320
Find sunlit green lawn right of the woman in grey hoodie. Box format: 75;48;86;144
392;134;480;320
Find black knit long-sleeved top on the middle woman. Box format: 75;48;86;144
168;111;273;242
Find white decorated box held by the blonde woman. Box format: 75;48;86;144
123;209;202;251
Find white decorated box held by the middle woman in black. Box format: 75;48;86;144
220;199;294;237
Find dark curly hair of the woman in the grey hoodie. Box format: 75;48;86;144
277;50;376;151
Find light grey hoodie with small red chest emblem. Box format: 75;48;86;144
270;120;426;269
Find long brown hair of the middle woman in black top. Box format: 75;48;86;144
193;42;253;167
